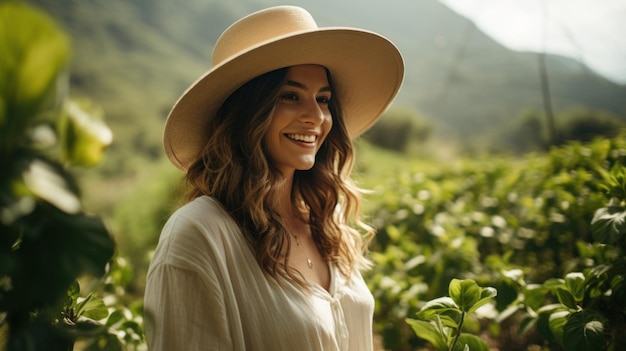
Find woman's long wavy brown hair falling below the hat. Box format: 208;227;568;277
186;68;373;286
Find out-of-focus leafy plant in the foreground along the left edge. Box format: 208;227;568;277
0;2;114;351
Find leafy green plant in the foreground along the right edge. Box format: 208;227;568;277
500;164;626;351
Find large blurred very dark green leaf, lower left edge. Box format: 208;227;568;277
0;202;114;311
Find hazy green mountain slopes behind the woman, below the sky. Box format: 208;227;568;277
27;0;626;161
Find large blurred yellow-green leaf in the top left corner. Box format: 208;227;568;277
0;1;70;145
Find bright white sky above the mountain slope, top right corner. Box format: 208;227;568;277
440;0;626;84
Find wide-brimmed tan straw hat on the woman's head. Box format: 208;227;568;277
163;6;404;171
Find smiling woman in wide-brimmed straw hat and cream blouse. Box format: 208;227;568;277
145;6;403;351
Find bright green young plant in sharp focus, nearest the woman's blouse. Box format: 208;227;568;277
406;279;497;351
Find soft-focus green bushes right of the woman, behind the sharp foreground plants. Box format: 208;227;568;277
366;137;626;350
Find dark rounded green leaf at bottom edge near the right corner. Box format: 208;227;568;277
563;310;605;351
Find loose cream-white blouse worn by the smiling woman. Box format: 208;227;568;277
144;196;374;351
